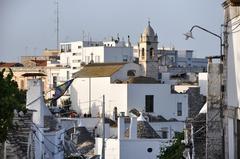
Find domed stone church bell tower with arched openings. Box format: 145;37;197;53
138;21;159;79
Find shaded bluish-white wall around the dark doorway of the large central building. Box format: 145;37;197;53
128;84;188;120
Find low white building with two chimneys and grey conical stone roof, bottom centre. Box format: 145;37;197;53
95;116;172;159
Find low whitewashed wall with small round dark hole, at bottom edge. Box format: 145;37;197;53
95;138;172;159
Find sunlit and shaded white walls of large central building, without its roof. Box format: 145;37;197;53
71;77;188;121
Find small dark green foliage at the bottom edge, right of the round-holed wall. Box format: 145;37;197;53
160;133;185;159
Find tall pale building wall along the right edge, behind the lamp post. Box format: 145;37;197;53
218;0;240;159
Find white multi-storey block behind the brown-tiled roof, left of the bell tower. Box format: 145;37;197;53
60;39;133;74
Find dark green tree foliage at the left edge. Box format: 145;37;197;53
0;69;26;143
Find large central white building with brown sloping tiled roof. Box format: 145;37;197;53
71;63;188;121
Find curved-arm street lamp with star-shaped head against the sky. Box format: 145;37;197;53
184;25;224;61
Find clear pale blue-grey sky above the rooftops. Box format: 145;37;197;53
0;0;224;62
